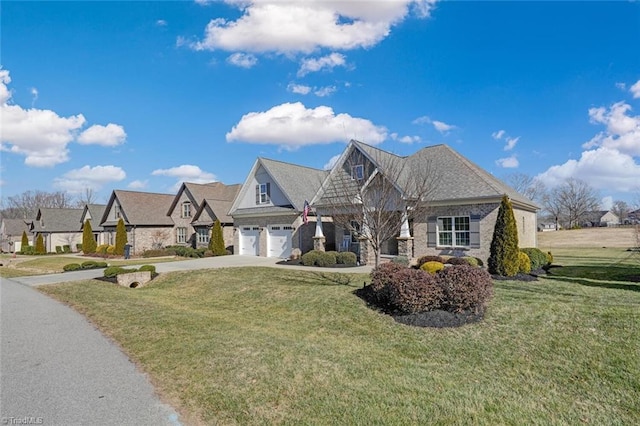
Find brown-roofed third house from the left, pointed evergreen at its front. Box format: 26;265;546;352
100;189;175;254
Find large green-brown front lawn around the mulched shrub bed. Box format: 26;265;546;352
40;262;640;425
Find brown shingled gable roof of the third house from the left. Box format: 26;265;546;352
100;189;175;226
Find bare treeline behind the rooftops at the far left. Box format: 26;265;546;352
2;191;74;219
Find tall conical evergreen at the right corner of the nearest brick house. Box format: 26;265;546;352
487;195;519;277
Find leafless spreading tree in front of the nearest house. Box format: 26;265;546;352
314;145;437;266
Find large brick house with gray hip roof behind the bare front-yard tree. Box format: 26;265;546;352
312;141;539;264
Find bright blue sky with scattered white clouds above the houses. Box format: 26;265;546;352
0;0;640;210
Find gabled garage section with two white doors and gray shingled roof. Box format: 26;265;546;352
229;158;333;258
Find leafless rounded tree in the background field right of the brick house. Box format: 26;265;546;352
543;178;600;228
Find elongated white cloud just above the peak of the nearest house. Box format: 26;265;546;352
226;102;387;150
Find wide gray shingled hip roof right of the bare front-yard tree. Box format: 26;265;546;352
316;141;538;208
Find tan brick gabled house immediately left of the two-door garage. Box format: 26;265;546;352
167;182;240;248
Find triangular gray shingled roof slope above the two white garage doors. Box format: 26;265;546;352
260;158;329;212
